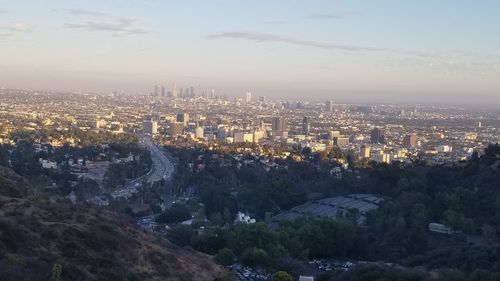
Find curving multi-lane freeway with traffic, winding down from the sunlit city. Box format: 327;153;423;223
111;134;174;199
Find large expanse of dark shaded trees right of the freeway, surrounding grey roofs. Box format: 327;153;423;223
165;145;500;280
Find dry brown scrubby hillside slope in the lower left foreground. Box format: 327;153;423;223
0;169;225;281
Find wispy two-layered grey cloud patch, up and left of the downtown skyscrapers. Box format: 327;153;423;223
64;9;149;36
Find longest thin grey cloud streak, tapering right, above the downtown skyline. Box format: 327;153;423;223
207;32;388;52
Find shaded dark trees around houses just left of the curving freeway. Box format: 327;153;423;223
0;134;151;197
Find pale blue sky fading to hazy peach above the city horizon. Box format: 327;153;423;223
0;0;500;105
